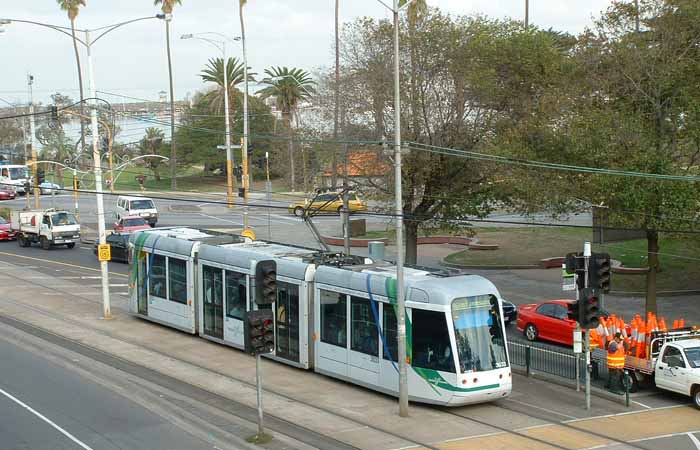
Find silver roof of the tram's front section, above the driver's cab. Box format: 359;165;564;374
315;266;500;305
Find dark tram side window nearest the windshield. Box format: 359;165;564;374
411;309;455;373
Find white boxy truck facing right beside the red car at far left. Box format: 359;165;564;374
10;209;80;250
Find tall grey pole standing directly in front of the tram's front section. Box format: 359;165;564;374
393;0;408;417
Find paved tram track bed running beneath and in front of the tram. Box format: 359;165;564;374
0;258;700;450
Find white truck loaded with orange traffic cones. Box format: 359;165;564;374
590;313;700;409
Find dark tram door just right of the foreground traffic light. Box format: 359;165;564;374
275;281;299;362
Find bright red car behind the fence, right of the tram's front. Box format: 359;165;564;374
518;300;576;345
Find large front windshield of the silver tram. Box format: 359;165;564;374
452;295;508;373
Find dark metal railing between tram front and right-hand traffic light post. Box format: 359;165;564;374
508;342;585;380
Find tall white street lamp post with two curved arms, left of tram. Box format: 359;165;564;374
0;14;168;319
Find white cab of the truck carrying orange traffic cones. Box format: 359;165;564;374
654;339;700;409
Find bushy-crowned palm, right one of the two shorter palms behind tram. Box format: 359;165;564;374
259;67;316;191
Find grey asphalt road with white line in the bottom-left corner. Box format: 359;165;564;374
0;326;235;450
